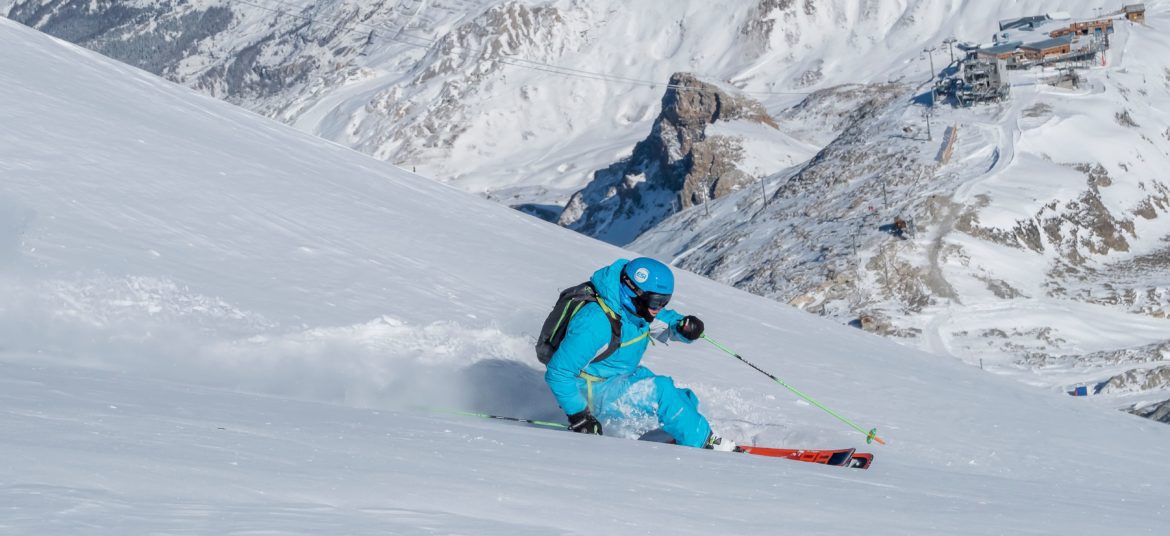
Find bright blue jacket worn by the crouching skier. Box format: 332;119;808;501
544;259;684;414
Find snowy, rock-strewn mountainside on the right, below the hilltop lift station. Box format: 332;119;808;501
631;8;1170;418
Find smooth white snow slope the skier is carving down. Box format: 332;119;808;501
0;20;1170;535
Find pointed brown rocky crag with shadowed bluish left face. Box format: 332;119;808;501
558;73;777;245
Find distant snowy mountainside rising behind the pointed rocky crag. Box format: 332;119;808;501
0;0;1100;201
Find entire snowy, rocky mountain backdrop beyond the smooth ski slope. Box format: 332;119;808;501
9;0;1170;418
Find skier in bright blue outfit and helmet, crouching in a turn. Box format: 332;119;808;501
544;257;735;451
